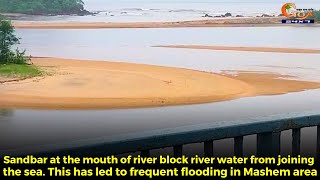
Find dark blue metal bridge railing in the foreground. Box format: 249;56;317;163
3;112;320;158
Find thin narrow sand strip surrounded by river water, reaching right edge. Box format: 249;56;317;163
154;45;320;54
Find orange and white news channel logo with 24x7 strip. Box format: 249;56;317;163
281;3;315;24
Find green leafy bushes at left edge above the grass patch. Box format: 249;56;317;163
0;18;29;64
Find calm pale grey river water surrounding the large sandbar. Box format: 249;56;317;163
0;27;320;154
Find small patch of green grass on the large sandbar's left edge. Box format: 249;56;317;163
0;64;43;78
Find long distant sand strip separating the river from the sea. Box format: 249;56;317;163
13;17;289;29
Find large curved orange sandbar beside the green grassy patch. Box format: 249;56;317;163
0;58;320;109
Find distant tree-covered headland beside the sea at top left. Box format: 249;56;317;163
0;0;89;15
